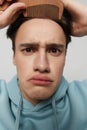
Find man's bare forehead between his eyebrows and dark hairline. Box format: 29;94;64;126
15;18;66;43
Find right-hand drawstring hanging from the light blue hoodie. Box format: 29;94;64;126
52;97;59;130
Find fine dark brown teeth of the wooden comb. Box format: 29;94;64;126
24;5;59;20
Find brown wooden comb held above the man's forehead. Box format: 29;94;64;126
0;0;64;20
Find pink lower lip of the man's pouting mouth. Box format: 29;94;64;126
30;79;52;86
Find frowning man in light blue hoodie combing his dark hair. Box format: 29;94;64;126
0;0;87;130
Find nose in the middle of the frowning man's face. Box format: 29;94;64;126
34;52;50;73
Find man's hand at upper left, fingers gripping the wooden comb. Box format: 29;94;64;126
0;0;26;29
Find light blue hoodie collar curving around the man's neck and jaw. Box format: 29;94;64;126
7;76;68;111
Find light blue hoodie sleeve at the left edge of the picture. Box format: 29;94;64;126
0;80;13;130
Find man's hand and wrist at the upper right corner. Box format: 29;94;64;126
61;0;87;37
